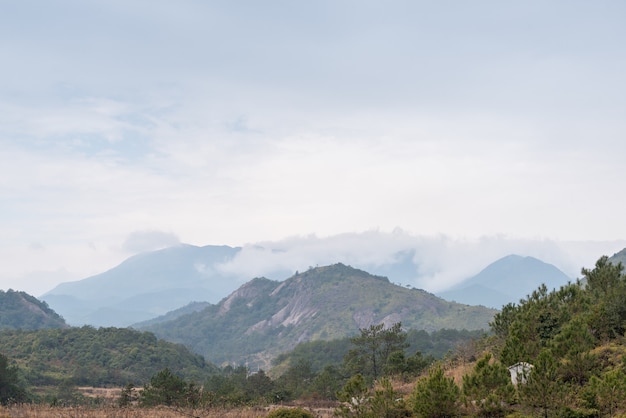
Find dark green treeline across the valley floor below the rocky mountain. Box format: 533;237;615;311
120;323;434;408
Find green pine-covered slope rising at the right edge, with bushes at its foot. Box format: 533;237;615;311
428;257;626;417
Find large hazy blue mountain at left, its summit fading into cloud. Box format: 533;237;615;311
42;245;240;326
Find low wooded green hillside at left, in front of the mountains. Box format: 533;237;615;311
0;326;216;386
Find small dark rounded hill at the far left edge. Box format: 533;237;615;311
0;290;68;330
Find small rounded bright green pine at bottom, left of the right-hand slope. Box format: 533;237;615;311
411;367;460;418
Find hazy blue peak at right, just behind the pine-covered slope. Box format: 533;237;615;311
437;255;571;308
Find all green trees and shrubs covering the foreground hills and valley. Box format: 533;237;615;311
0;251;626;418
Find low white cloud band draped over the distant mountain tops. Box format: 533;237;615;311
219;229;626;291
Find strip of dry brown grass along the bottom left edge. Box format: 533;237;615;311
0;405;333;418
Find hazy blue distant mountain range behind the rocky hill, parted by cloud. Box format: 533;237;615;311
41;244;568;327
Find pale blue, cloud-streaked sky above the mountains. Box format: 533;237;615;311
0;0;626;294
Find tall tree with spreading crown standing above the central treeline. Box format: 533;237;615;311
344;322;408;380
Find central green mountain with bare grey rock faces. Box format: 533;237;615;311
136;264;495;368
